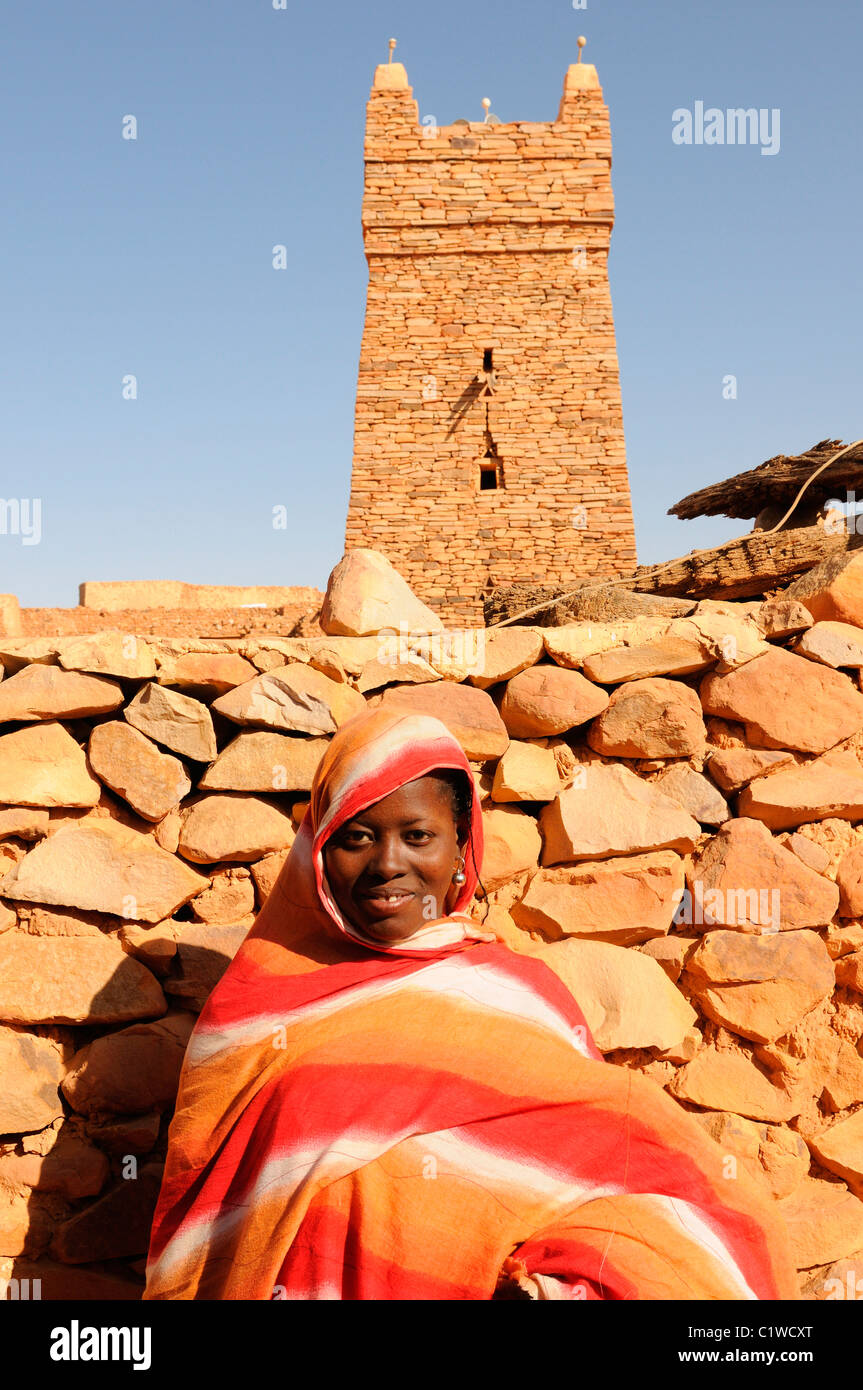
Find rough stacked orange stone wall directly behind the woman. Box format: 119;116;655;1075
0;598;863;1300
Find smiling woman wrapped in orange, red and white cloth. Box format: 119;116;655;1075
145;706;798;1300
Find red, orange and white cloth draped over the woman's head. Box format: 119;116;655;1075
250;705;495;956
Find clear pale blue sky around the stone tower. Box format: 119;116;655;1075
0;0;863;606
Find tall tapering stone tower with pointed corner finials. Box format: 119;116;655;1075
345;43;636;626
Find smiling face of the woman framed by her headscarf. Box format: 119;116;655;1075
324;777;463;942
